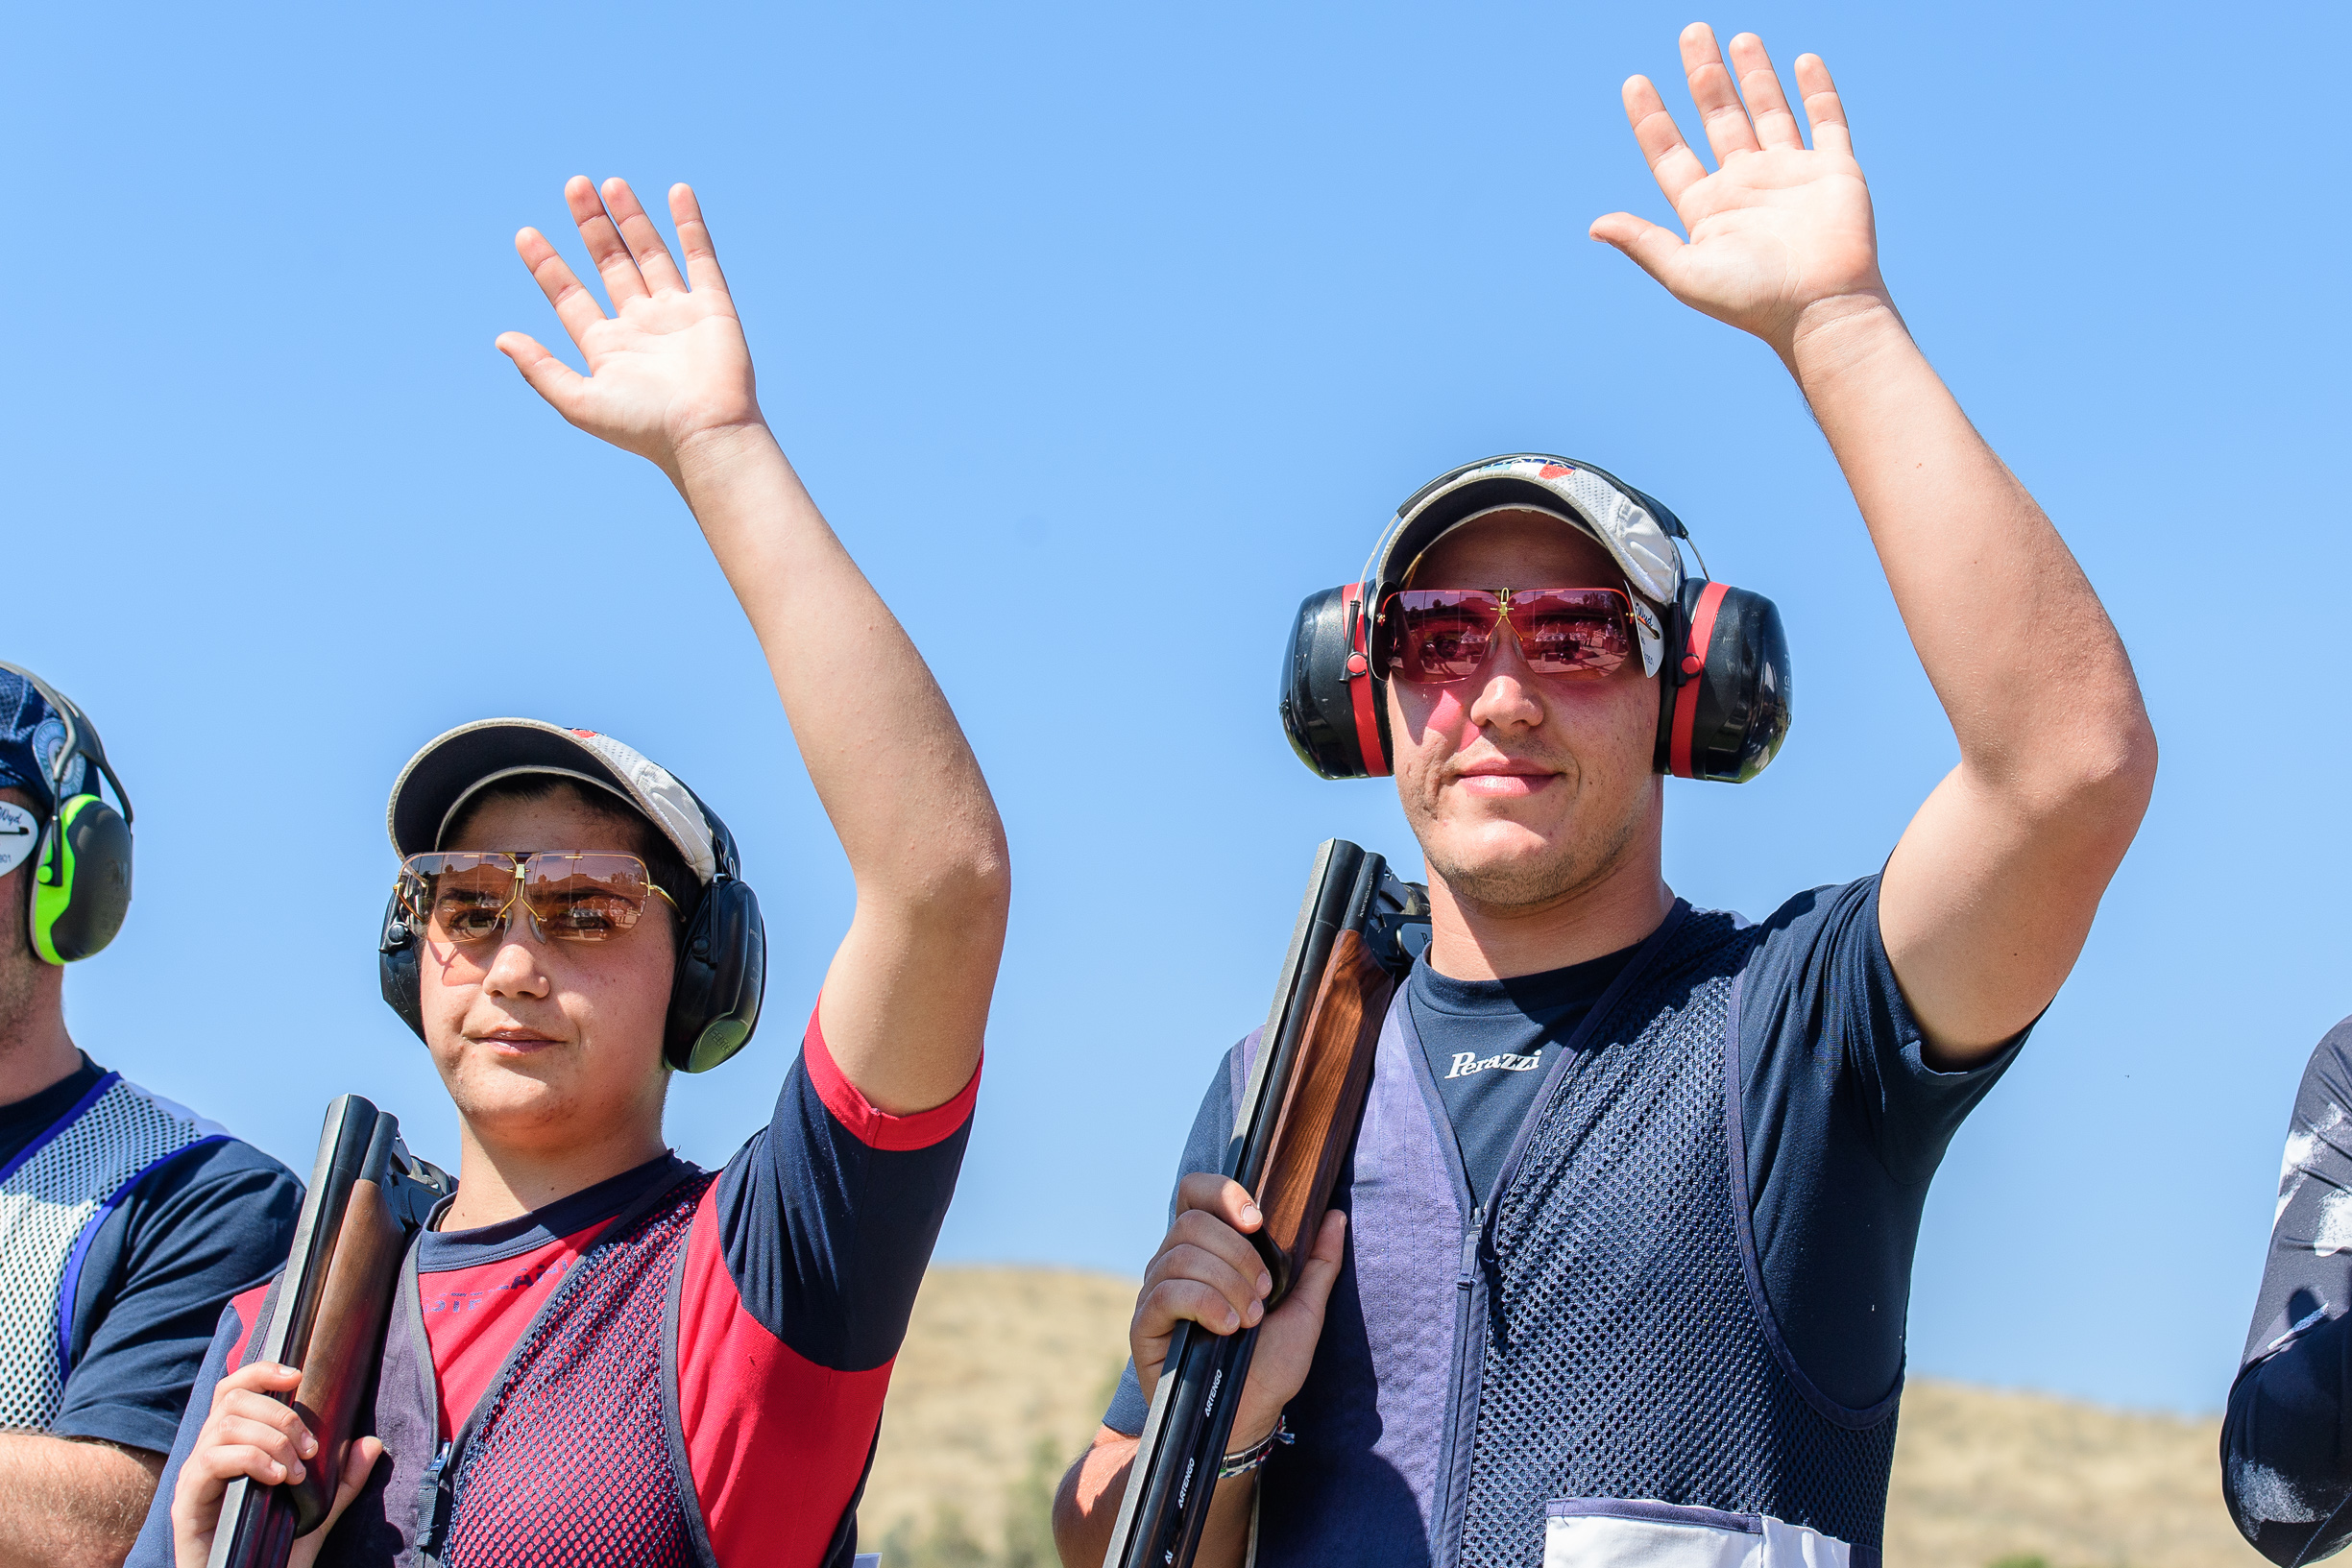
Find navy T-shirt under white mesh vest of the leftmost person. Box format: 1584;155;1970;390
0;1055;301;1453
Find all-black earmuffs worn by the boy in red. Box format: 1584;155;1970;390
376;795;766;1072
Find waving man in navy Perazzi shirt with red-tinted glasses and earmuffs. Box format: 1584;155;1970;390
1056;26;2154;1568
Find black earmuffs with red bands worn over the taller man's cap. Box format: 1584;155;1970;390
1279;454;1790;783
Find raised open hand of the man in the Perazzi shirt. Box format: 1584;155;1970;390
1592;21;1886;360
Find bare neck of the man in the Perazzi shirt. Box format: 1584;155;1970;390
1430;828;1675;980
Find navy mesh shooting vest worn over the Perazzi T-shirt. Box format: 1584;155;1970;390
1235;905;1896;1568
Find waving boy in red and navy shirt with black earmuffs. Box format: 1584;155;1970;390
134;179;1009;1568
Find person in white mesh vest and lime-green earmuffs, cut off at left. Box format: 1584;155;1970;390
0;665;301;1568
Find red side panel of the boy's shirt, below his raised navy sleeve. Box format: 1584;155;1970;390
677;1184;903;1568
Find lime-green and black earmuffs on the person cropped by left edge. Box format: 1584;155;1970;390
0;663;132;964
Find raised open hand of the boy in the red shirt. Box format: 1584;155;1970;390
498;177;762;482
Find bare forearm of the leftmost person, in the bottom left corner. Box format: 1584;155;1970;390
0;1432;162;1568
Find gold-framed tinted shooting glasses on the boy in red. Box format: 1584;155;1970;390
395;849;677;945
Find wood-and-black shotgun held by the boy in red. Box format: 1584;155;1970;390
205;1096;456;1568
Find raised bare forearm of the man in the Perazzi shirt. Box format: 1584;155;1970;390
1782;296;2152;799
